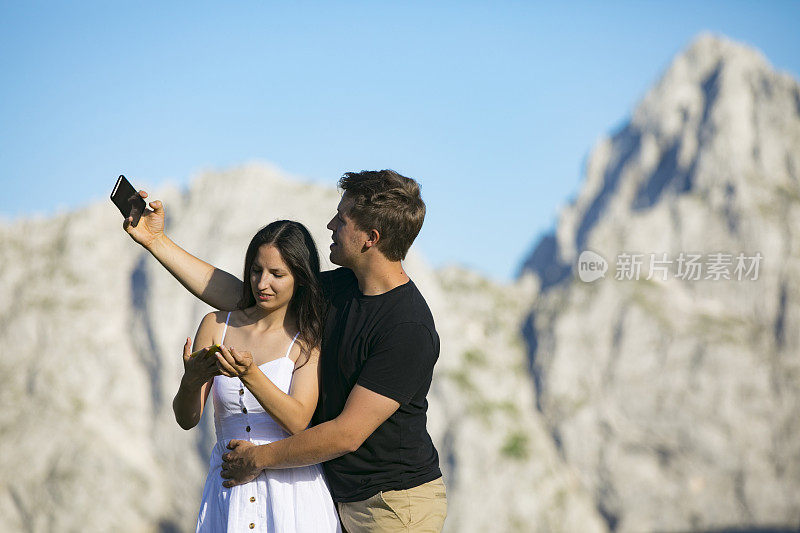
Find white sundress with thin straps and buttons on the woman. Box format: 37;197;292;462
196;313;341;533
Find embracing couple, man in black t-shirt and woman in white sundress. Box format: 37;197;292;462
125;170;447;533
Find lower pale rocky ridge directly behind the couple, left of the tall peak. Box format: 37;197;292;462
0;165;605;531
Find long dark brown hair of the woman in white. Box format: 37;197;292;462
239;220;326;360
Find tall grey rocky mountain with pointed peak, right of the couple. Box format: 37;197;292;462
523;36;800;531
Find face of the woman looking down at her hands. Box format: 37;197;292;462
250;244;294;311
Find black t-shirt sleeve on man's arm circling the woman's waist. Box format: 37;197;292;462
357;322;438;404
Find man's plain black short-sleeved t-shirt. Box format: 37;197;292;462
315;268;442;502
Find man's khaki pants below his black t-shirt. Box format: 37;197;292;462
336;478;447;533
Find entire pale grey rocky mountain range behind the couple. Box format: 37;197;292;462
0;32;800;532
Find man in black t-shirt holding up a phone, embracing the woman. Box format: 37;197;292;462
125;170;447;533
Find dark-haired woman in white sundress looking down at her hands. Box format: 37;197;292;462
173;220;340;533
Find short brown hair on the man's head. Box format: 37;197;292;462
339;170;425;261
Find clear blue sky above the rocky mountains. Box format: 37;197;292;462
0;1;800;280
